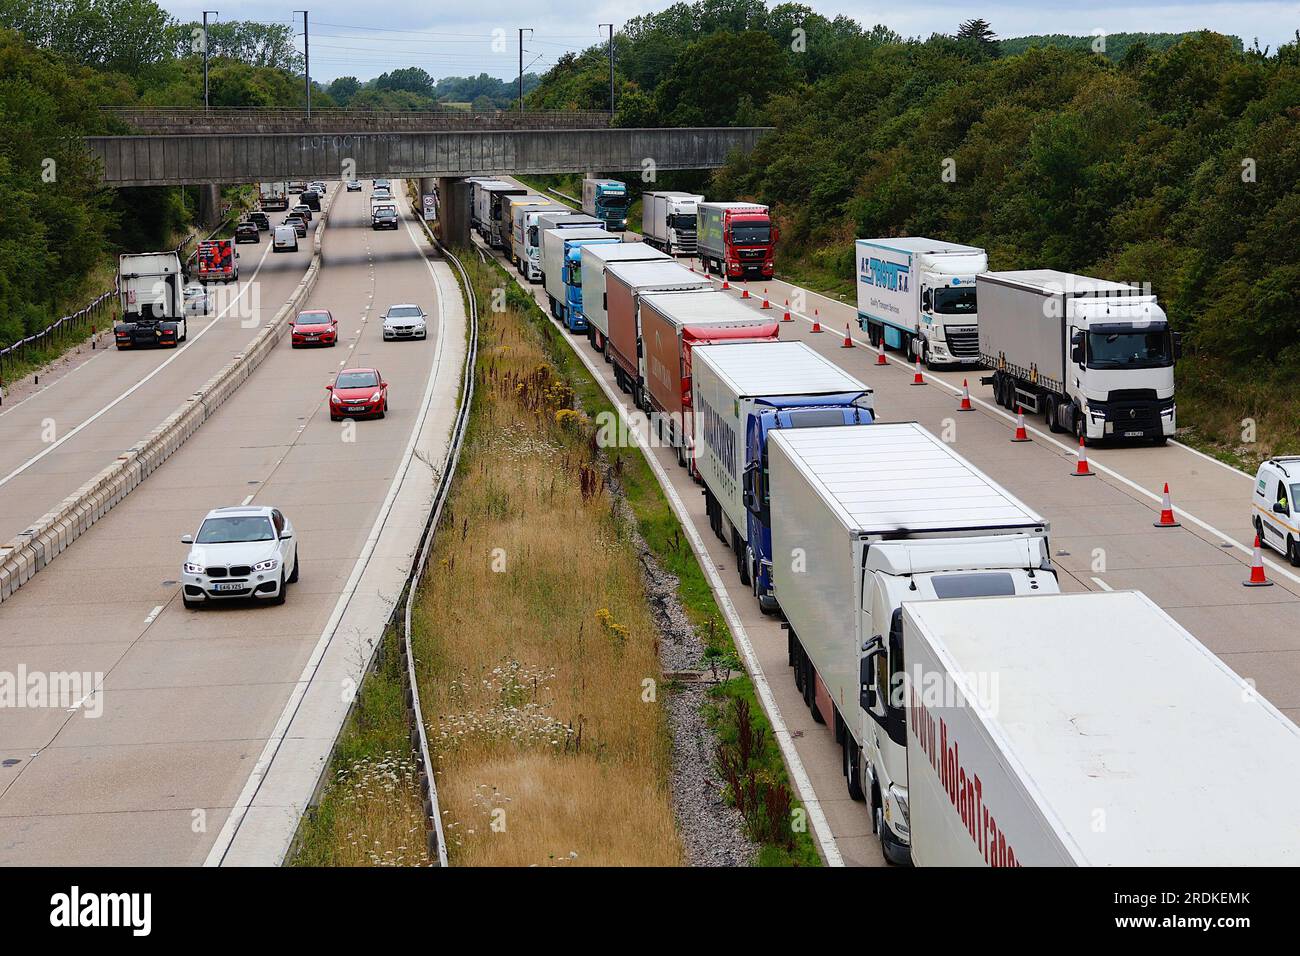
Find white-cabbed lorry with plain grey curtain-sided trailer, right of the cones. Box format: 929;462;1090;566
976;269;1182;445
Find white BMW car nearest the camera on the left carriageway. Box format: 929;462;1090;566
181;505;298;609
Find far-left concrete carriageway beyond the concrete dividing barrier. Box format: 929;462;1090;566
0;209;323;554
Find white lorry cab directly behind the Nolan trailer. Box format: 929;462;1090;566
848;535;1061;864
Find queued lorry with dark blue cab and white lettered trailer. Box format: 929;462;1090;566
691;340;875;600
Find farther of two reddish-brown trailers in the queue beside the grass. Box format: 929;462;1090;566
605;260;712;402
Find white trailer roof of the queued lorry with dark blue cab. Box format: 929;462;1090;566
692;342;871;395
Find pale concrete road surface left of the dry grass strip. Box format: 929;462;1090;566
0;187;465;865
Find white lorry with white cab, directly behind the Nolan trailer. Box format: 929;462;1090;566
767;423;1055;864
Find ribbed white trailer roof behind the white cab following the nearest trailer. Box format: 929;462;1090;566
769;421;1048;535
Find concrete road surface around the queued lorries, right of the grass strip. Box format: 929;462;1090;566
480;187;1300;866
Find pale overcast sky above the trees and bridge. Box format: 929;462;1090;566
160;0;1300;82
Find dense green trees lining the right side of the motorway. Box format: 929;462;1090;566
532;0;1300;447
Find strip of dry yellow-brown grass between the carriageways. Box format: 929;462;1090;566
416;268;683;866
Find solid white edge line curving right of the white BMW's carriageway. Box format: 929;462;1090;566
210;192;454;866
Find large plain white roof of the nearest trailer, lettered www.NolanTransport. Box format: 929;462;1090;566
904;590;1300;866
